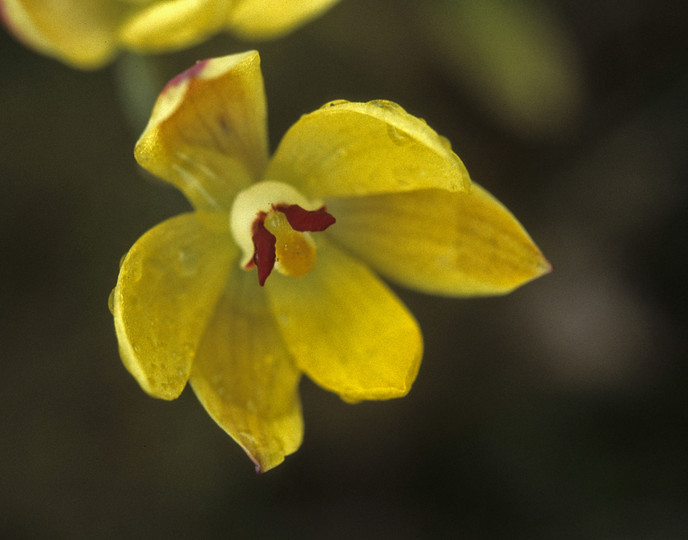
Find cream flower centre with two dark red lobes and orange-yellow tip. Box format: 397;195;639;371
229;180;335;286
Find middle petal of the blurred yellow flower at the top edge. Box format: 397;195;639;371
120;0;224;52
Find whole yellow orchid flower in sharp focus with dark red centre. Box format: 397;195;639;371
110;51;550;471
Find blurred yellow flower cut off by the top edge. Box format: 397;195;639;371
0;0;339;69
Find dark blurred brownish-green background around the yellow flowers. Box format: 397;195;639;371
0;0;688;539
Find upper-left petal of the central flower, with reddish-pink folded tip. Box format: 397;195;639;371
134;51;267;210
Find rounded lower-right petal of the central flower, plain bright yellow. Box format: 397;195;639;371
265;236;423;401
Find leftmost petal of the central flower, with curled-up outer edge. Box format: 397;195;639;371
110;213;238;399
